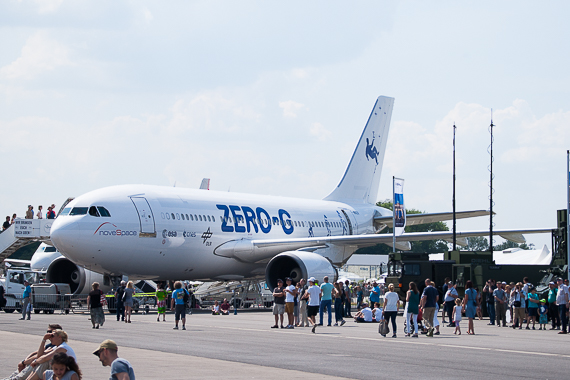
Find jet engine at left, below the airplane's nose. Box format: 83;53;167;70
46;256;111;294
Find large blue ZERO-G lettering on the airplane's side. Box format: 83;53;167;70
216;205;294;235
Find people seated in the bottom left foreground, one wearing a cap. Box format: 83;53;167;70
4;324;135;380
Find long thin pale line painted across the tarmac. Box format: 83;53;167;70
186;325;570;358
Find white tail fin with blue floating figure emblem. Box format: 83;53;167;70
325;96;394;204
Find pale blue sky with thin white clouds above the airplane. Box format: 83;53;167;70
0;0;570;248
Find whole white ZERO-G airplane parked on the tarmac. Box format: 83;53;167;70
50;96;551;289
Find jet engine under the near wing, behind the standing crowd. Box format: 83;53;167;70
265;251;338;289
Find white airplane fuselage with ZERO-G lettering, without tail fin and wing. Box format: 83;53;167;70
51;185;391;280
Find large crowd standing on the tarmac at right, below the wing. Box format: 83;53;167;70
271;277;570;338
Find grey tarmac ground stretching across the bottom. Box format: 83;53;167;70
0;311;570;380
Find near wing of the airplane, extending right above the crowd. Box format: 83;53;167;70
214;228;552;262
